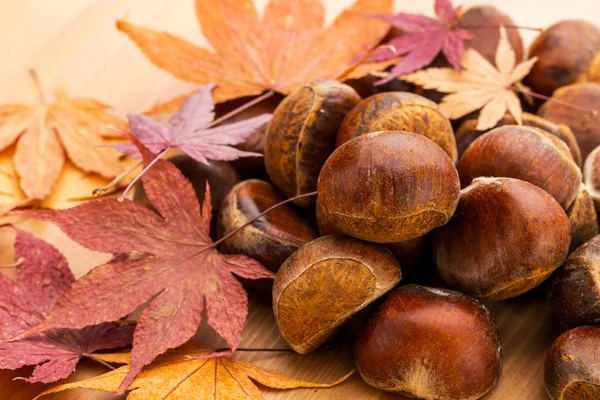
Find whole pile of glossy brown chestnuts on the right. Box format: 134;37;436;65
138;6;600;399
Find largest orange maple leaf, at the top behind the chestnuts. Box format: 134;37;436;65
117;0;393;113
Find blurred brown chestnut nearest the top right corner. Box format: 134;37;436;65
523;20;600;96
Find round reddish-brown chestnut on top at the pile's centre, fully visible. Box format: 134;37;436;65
317;131;460;243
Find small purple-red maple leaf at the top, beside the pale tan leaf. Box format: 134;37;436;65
369;0;475;84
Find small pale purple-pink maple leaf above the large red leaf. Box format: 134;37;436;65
113;84;271;164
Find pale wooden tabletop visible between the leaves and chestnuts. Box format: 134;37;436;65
0;0;600;400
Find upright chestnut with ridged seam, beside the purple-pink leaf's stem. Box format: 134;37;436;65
265;80;360;206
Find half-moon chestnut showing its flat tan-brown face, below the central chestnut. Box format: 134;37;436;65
273;235;402;354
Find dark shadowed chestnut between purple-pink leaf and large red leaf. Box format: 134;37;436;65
133;154;240;219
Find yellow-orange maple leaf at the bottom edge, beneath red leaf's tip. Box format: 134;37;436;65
36;344;353;400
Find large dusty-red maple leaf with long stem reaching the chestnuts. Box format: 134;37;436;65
15;139;273;389
